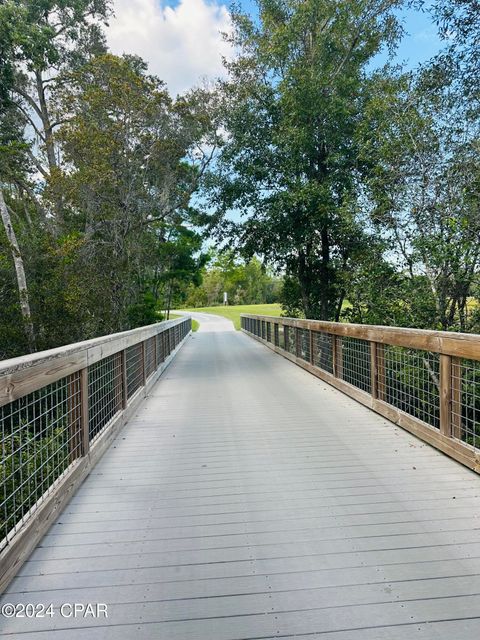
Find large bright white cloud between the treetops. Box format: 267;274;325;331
107;0;230;94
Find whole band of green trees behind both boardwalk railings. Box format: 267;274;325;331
0;0;480;357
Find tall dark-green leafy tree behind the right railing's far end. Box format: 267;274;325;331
208;0;401;320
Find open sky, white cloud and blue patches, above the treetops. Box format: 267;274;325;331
107;0;441;94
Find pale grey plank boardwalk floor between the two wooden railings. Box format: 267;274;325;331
0;312;480;640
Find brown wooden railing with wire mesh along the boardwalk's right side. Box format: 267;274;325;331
241;314;480;473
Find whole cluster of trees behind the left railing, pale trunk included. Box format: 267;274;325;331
0;5;218;357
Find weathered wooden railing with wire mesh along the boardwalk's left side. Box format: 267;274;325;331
0;317;191;592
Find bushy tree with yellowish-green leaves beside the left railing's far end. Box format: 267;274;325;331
56;54;215;332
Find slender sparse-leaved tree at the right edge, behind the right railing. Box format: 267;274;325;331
361;68;480;330
